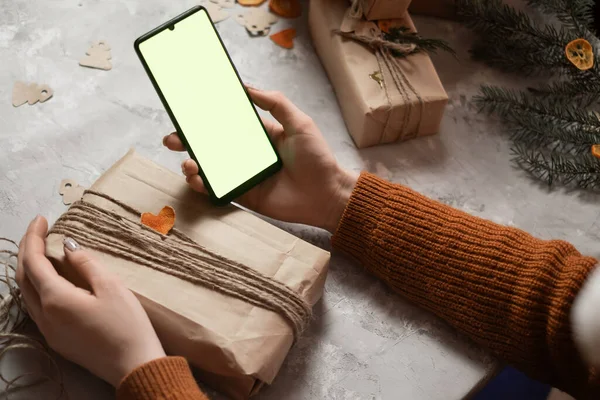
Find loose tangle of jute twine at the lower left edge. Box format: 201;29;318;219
0;237;68;400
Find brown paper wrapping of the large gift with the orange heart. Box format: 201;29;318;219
47;150;329;399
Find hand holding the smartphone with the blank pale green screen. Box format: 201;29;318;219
163;87;358;233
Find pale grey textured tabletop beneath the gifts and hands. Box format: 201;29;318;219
5;0;600;400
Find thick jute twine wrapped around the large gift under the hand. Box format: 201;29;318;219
49;190;311;338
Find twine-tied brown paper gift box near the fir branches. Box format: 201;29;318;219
309;0;448;148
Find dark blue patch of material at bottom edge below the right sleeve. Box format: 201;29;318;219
473;367;551;400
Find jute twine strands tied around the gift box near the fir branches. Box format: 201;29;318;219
333;16;425;143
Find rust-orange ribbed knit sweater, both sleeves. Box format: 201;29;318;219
117;174;600;400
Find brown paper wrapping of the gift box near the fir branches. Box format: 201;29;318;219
308;0;448;148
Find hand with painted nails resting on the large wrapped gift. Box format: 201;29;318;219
16;217;165;387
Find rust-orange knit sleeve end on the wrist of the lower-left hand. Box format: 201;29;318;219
117;357;208;400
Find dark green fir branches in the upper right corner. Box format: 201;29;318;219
464;0;600;189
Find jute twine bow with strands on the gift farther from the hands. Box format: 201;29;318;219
333;5;424;143
